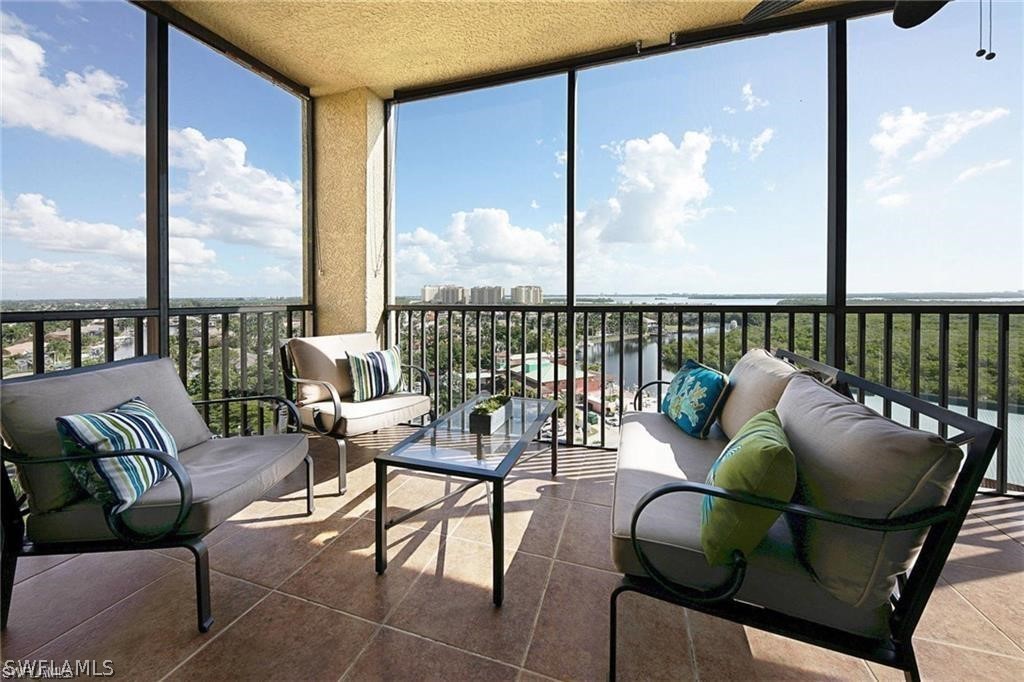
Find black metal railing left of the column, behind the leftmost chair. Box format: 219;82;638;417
0;305;313;435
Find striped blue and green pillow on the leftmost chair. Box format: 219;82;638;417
57;397;178;513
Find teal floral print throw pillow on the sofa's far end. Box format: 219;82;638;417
662;359;729;438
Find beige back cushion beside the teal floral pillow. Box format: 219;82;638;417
718;348;798;438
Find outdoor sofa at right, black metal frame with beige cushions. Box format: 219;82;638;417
609;349;1000;680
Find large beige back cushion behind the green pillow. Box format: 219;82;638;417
778;375;964;607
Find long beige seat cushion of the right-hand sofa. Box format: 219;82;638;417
611;413;889;637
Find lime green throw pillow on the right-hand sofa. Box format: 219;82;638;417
700;410;797;565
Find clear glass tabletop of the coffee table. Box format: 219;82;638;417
377;394;557;478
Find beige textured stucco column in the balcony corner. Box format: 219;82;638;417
314;88;384;334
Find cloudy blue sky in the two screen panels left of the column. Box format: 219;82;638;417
0;2;302;299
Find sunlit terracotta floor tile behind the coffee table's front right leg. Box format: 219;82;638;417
452;486;569;557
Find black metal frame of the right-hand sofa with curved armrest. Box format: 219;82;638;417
608;350;1002;680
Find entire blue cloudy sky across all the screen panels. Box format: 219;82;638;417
0;2;1024;299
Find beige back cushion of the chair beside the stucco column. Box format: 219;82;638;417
288;332;380;404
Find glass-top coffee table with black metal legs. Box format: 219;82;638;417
374;393;558;606
